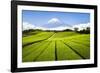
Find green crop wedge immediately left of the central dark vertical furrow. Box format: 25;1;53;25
36;41;55;61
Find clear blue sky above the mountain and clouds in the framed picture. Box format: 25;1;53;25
22;10;90;26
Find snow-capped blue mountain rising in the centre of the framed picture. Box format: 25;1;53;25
41;18;71;30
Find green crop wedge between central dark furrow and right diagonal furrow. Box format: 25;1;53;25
57;41;82;60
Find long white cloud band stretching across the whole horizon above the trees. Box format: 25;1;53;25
23;22;90;31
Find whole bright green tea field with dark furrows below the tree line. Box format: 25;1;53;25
22;31;90;62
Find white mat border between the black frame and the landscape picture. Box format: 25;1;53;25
17;5;94;68
